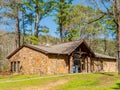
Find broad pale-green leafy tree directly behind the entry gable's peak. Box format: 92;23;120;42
64;5;102;44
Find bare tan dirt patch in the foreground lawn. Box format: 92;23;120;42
20;80;68;90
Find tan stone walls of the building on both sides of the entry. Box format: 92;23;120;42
9;47;117;74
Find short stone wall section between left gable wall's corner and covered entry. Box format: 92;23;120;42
48;54;69;74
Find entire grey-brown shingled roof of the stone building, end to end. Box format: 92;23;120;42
7;39;115;59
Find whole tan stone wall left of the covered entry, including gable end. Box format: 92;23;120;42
9;47;68;74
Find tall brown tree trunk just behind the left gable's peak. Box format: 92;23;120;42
15;7;20;48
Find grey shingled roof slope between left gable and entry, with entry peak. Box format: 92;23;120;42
29;39;93;54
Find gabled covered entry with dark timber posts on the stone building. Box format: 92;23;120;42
70;43;94;73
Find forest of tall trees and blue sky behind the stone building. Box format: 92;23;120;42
0;0;120;71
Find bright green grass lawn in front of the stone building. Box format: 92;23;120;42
0;73;120;90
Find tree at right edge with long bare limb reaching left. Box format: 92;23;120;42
83;0;120;75
